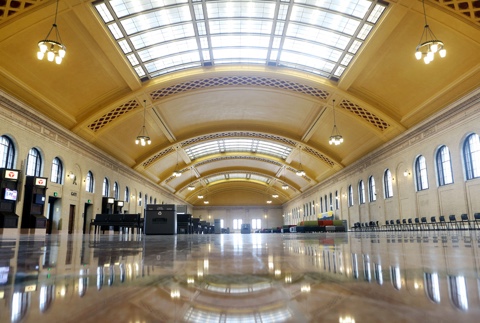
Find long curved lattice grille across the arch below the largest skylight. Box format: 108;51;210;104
150;76;329;101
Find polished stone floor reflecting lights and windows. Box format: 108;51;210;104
0;231;480;323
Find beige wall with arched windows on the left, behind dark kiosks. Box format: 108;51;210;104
0;91;191;233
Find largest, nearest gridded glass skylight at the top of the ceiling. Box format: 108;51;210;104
94;0;385;78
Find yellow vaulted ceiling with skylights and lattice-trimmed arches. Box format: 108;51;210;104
0;0;480;205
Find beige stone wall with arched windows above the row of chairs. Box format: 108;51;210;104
283;89;480;226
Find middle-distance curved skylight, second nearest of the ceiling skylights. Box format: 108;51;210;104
185;138;292;160
